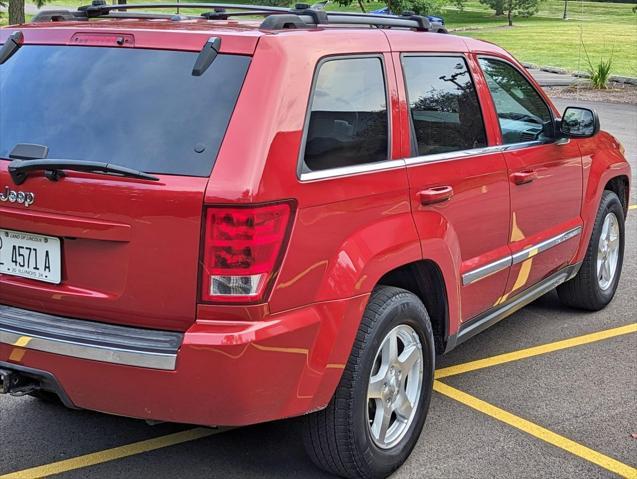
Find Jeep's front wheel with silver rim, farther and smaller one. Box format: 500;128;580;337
557;191;624;311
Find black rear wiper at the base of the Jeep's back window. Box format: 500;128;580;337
9;159;159;185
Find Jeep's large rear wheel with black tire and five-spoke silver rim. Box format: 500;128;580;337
304;286;435;478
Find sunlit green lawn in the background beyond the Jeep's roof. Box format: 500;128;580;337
8;0;637;77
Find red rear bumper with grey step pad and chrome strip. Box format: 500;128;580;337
0;295;367;426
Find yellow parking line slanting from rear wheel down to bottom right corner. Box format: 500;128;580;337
434;381;637;479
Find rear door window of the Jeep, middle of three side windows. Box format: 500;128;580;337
402;56;487;155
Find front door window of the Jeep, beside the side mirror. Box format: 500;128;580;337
480;58;553;145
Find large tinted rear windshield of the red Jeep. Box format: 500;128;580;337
0;46;250;176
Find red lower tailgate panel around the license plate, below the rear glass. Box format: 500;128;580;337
0;171;207;330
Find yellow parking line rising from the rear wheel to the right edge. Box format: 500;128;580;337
436;323;637;379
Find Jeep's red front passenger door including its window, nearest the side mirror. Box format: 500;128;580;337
478;57;582;302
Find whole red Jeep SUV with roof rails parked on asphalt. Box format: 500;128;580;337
0;2;631;477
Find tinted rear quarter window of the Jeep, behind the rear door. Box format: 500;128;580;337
304;58;389;171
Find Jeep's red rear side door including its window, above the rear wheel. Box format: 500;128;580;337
399;53;510;321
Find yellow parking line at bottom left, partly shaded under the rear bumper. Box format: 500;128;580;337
0;427;222;479
